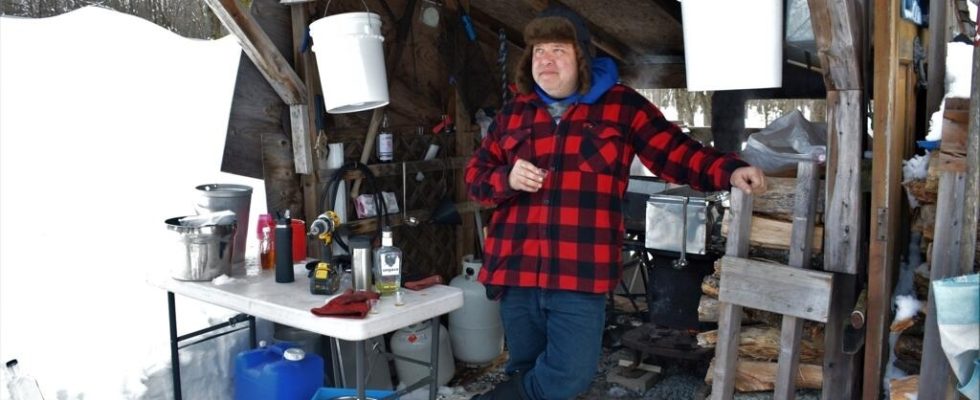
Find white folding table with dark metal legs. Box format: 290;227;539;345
147;264;463;400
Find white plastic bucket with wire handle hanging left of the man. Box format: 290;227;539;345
310;12;388;114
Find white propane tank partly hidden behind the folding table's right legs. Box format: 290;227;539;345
391;320;456;386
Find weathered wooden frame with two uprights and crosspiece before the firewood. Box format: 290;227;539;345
711;161;833;400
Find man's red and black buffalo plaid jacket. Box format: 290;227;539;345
466;85;747;293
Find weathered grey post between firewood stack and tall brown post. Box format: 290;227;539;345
809;0;860;400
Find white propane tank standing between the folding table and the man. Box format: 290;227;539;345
449;254;504;365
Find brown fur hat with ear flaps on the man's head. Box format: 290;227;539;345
514;6;593;94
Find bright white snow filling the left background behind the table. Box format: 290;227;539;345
0;7;271;400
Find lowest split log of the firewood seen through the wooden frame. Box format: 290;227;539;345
704;359;823;392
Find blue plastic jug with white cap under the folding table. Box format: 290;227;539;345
235;342;323;400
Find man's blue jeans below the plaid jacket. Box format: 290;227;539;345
500;287;606;400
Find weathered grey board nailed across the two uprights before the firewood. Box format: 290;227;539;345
718;256;832;322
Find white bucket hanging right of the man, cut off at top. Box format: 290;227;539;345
681;0;783;90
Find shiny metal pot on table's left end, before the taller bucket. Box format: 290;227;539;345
165;217;237;281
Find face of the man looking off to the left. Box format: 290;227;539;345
531;43;578;99
